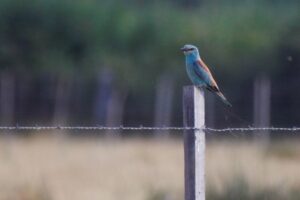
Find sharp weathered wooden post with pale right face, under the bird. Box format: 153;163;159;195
183;86;205;200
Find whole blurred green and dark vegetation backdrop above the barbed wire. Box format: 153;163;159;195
0;0;300;127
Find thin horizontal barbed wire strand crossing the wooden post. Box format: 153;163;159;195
0;125;300;133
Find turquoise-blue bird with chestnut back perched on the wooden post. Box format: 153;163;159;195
181;44;232;107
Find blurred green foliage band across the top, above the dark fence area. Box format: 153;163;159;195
0;0;300;88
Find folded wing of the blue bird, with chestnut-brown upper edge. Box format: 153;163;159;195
193;59;220;92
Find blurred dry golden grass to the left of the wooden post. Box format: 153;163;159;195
0;137;183;200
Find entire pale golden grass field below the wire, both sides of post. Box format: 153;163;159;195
0;135;300;200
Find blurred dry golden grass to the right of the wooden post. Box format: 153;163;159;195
206;141;300;194
